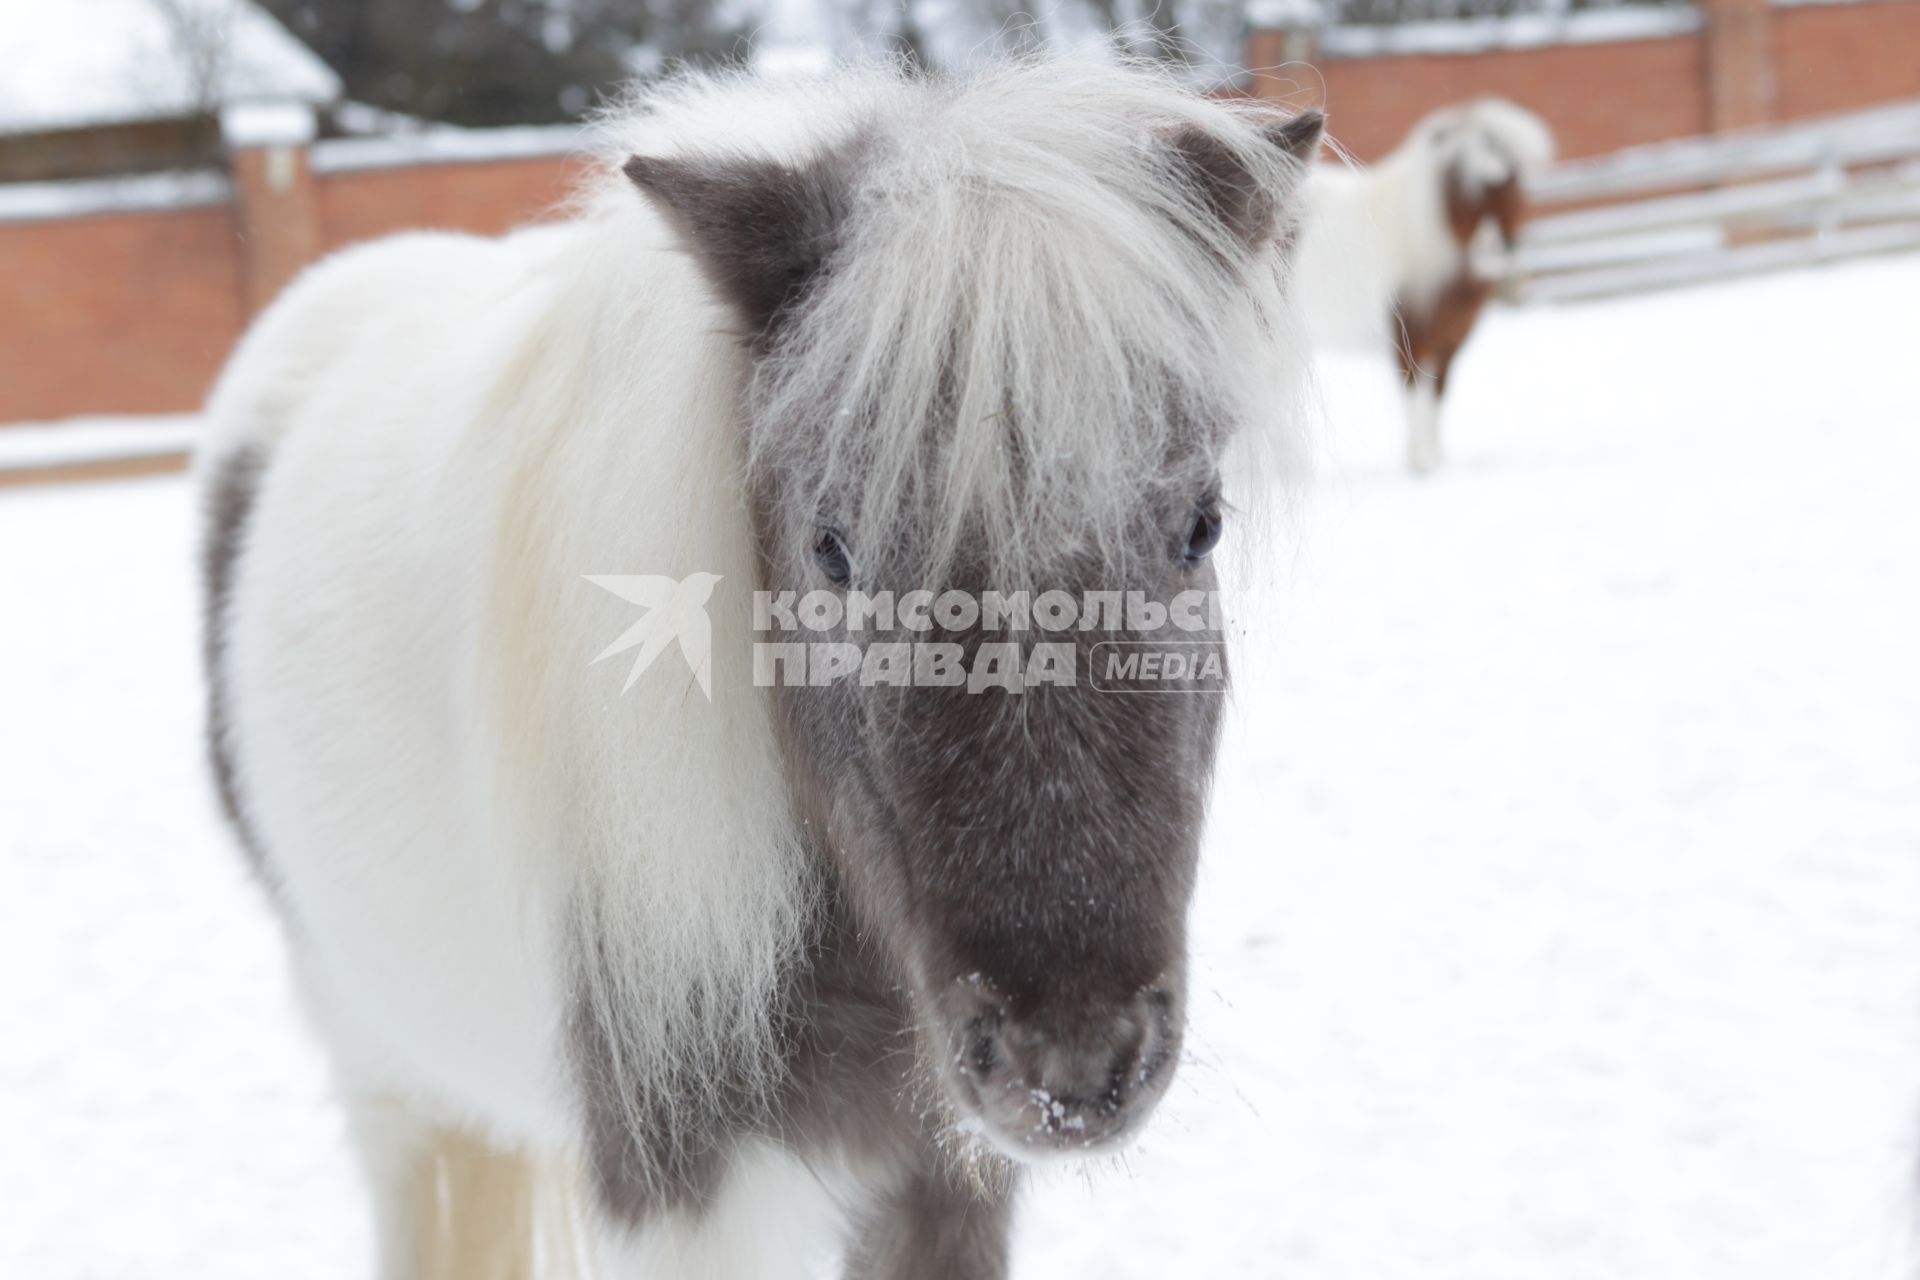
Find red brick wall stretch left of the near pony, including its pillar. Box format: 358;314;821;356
0;148;572;422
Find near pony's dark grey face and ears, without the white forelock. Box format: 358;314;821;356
628;105;1321;1155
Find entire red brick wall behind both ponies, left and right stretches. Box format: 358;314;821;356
0;0;1920;422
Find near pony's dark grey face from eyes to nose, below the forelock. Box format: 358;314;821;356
760;502;1225;1155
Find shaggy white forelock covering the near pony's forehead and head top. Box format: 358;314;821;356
583;56;1298;568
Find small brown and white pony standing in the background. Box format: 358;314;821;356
1298;98;1553;474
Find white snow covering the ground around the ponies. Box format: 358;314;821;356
0;257;1920;1280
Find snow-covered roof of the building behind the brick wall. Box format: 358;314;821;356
0;0;340;132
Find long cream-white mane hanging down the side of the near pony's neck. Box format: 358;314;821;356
486;192;814;1174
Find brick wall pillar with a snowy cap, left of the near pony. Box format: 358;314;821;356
221;102;324;315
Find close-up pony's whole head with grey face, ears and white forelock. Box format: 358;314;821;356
626;59;1321;1155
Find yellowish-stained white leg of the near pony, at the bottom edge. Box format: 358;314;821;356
413;1128;593;1280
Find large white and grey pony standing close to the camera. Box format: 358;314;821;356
200;59;1321;1280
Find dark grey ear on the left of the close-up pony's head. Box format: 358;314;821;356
622;155;847;347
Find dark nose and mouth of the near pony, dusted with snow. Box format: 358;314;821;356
948;986;1179;1159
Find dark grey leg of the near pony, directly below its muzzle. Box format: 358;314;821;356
847;1169;1014;1280
